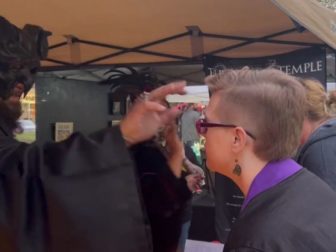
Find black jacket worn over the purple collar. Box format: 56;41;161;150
224;169;336;252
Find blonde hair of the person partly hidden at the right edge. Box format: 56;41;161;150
299;79;330;122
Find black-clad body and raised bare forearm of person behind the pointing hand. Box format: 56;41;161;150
131;125;191;252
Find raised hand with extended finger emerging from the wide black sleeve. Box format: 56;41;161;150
120;81;185;145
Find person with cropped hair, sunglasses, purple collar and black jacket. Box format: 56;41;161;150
201;68;336;252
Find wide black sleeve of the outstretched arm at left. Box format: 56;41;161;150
0;128;151;252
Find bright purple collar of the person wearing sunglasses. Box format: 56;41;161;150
241;159;302;211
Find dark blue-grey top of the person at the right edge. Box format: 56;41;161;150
296;119;336;191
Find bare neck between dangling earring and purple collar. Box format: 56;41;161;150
228;155;267;197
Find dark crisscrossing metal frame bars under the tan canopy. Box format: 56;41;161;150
42;26;328;71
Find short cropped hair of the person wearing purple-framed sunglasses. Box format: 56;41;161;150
206;67;305;161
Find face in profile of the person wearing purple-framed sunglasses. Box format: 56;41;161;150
204;94;234;175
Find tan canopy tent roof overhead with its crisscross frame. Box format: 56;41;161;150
1;0;336;68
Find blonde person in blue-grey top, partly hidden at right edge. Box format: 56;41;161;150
296;79;336;190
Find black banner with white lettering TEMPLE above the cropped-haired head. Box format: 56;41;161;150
203;48;326;86
